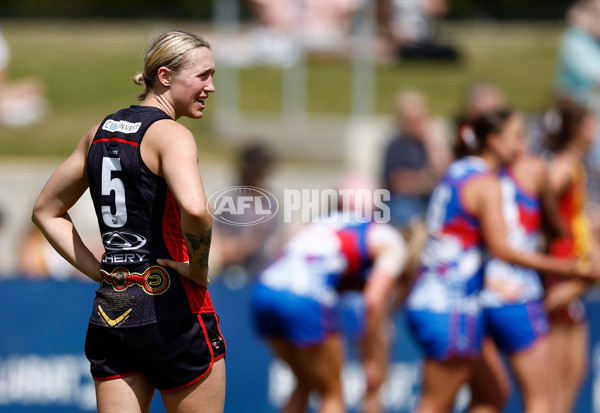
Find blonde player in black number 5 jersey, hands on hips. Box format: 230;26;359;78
33;31;225;413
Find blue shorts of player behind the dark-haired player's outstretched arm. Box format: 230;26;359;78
483;301;550;354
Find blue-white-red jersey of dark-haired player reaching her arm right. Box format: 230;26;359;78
407;156;490;313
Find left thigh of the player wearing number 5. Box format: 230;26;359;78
95;374;154;413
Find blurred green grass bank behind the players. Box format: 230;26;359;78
0;21;562;156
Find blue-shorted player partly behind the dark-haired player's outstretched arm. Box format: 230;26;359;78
470;148;561;412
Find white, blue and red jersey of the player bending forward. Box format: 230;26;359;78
260;214;379;306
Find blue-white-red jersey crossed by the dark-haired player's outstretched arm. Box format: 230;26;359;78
481;168;543;307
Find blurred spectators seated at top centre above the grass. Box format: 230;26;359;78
217;0;460;67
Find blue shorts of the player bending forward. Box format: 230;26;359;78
252;284;340;347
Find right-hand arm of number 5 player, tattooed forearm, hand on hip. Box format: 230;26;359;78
148;121;212;285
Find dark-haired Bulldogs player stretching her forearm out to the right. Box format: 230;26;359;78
407;109;592;413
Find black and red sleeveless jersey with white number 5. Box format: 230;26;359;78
87;106;214;327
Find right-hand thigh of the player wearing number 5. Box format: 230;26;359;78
162;359;226;413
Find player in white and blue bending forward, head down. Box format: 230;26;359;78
252;175;407;413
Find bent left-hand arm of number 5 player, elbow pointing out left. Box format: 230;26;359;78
32;126;100;281
